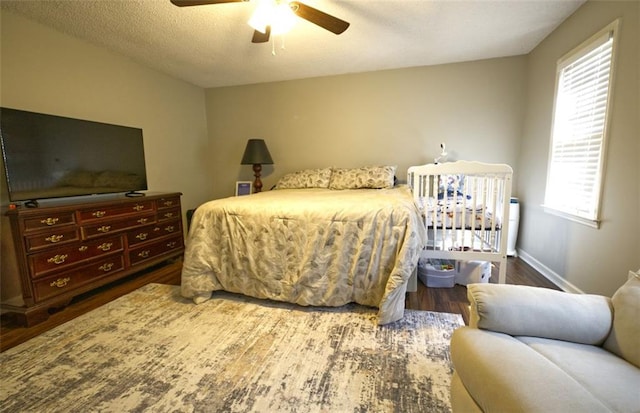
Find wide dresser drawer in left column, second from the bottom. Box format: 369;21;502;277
29;237;122;278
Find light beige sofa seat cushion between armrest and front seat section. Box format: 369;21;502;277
517;337;640;412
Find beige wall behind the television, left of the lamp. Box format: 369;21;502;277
0;11;212;298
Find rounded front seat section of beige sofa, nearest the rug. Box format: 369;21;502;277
451;327;610;413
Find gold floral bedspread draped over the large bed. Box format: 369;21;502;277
181;186;427;324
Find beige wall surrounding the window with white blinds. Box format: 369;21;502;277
518;1;640;294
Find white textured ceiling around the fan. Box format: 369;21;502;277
0;0;584;87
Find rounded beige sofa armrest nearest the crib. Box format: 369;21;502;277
467;284;613;345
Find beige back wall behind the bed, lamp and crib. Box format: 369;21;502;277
207;56;526;197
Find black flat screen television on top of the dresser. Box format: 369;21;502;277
0;108;147;204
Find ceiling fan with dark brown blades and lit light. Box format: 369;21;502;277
171;0;349;43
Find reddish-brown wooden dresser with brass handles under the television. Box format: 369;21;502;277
2;193;184;326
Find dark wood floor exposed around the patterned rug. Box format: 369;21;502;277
0;258;558;351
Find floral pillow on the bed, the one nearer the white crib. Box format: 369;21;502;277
329;166;397;189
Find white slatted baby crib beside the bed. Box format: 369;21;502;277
407;161;513;284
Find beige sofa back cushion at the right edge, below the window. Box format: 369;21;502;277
604;273;640;367
